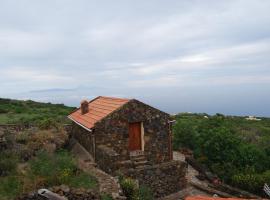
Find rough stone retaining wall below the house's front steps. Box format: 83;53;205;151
126;161;187;198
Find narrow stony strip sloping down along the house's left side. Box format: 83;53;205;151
69;143;125;199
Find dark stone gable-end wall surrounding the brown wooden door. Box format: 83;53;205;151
94;100;170;164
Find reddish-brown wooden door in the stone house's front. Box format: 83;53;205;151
129;122;141;151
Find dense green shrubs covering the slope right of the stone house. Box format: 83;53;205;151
173;113;270;194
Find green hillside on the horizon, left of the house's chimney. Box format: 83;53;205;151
0;98;75;125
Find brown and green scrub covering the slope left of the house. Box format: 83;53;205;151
0;126;97;200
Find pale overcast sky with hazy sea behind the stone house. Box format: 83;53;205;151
0;0;270;116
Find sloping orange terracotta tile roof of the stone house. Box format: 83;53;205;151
68;96;130;129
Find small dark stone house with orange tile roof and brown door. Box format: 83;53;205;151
68;96;185;196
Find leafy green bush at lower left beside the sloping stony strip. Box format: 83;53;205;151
29;150;96;189
